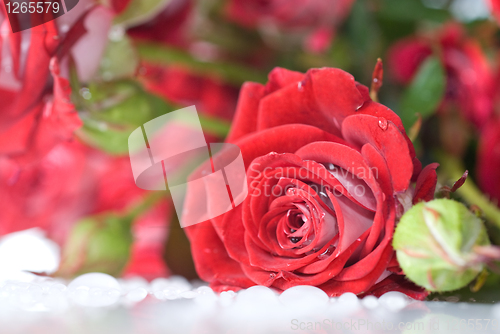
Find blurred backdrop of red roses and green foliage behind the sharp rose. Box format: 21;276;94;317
0;0;500;299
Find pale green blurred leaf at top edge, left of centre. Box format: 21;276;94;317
114;0;170;26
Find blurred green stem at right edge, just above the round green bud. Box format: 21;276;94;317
438;153;500;228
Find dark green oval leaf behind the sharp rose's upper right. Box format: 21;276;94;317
400;56;446;129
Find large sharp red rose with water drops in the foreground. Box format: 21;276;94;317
186;68;436;298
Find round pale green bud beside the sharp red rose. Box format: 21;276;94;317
393;199;490;291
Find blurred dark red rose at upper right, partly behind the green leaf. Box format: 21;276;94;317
388;24;495;128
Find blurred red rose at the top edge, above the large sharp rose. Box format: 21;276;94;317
226;0;354;52
